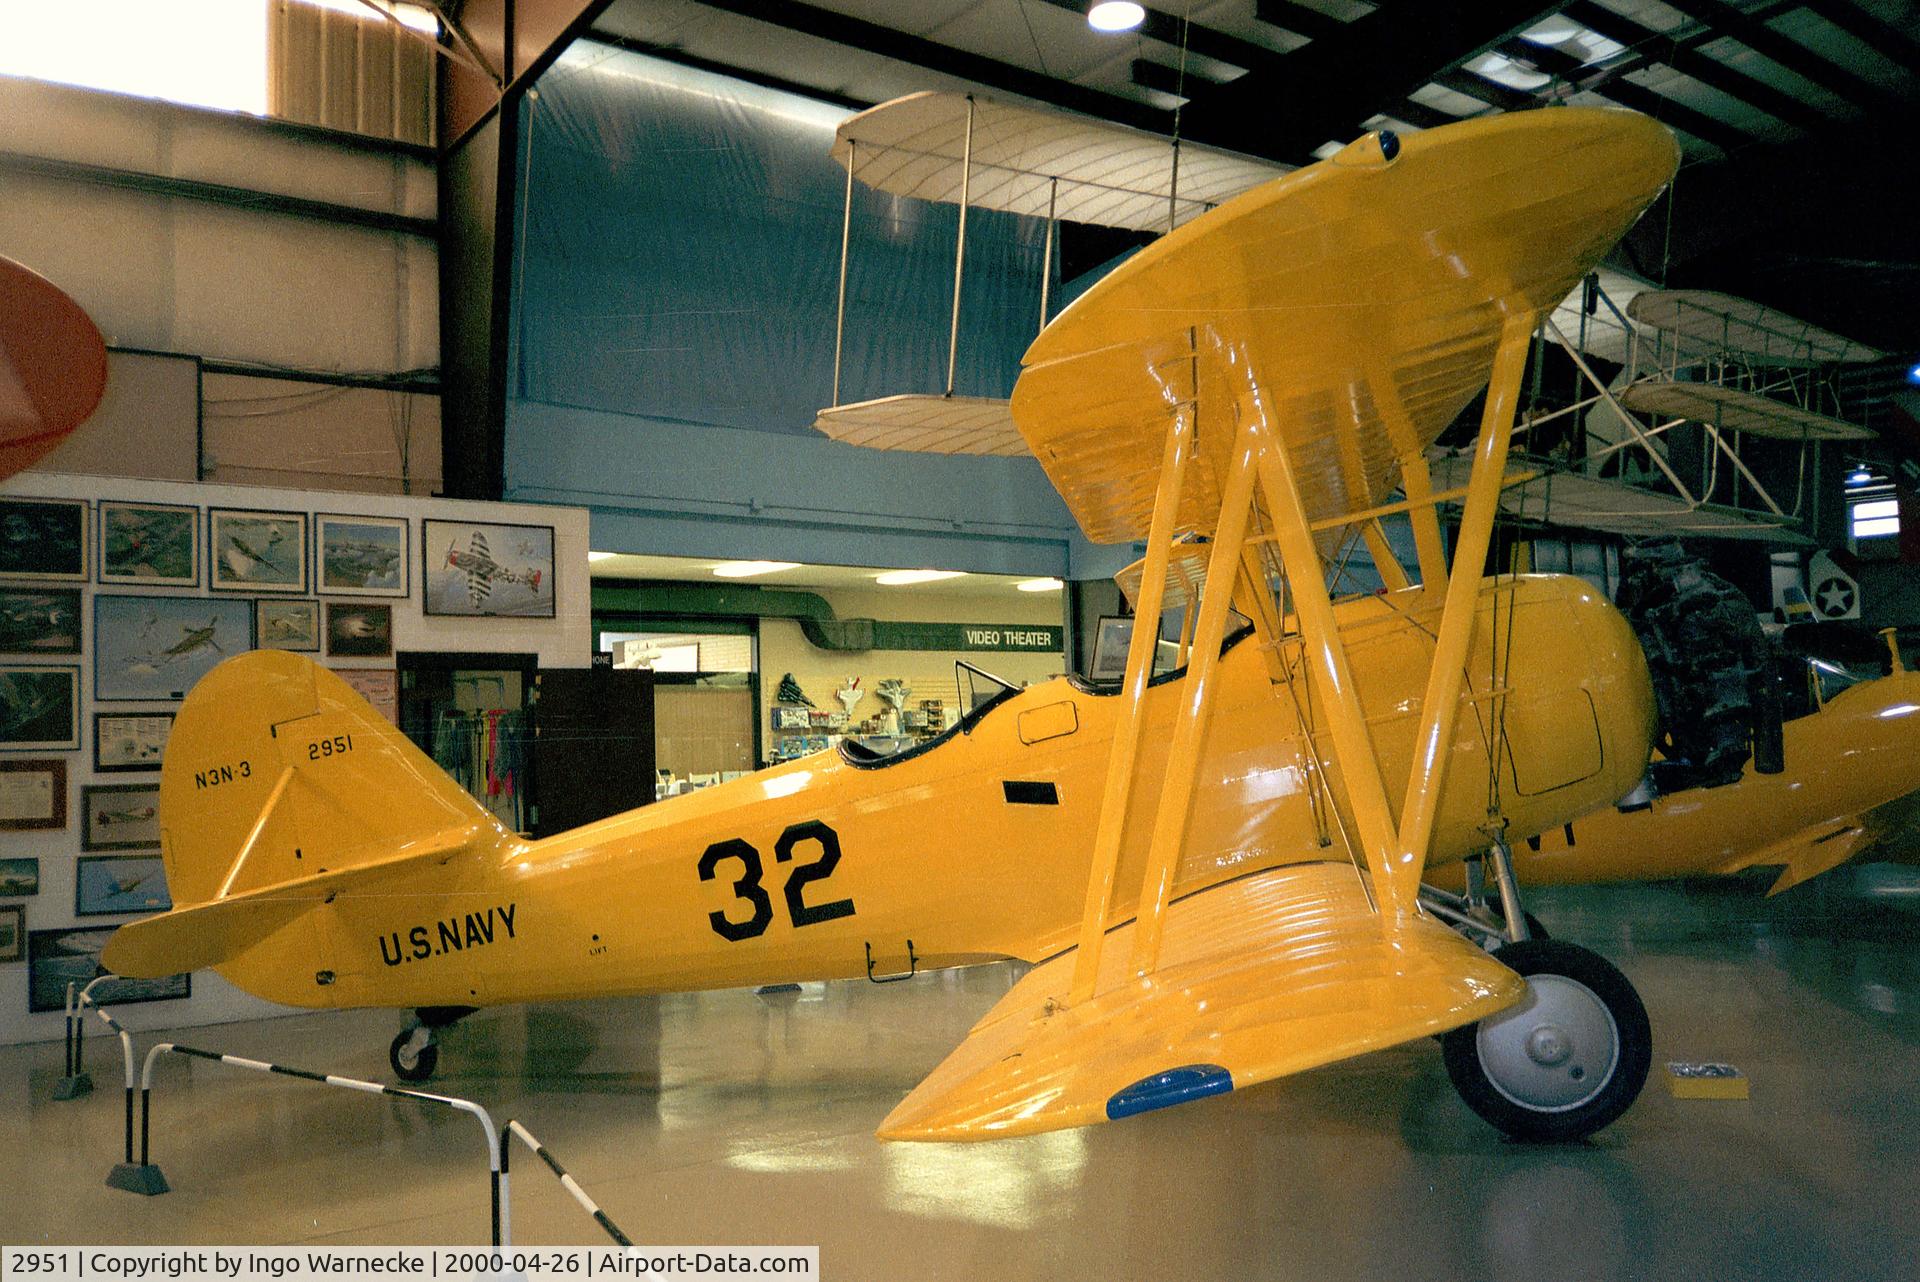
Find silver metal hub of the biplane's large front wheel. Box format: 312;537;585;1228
1476;975;1620;1113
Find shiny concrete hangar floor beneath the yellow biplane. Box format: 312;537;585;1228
0;866;1920;1282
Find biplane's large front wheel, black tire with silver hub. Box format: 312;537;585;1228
1440;938;1653;1144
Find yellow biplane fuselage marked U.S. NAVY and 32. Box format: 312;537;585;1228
210;576;1651;1006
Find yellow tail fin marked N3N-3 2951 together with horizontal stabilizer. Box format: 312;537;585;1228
104;651;509;975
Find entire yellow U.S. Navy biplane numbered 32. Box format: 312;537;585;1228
106;107;1678;1140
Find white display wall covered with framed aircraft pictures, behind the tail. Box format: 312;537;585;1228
0;474;589;1044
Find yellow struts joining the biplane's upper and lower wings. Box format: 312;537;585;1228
1068;313;1532;1006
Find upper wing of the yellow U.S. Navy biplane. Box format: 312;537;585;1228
1014;107;1678;543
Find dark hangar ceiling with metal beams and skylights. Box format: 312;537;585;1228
593;0;1920;353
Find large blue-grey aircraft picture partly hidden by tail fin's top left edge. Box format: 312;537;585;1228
94;593;253;702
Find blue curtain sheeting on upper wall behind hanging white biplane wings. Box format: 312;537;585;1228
511;42;1044;434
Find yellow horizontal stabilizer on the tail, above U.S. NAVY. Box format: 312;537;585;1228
100;823;497;979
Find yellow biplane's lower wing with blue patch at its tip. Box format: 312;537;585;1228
879;864;1524;1140
